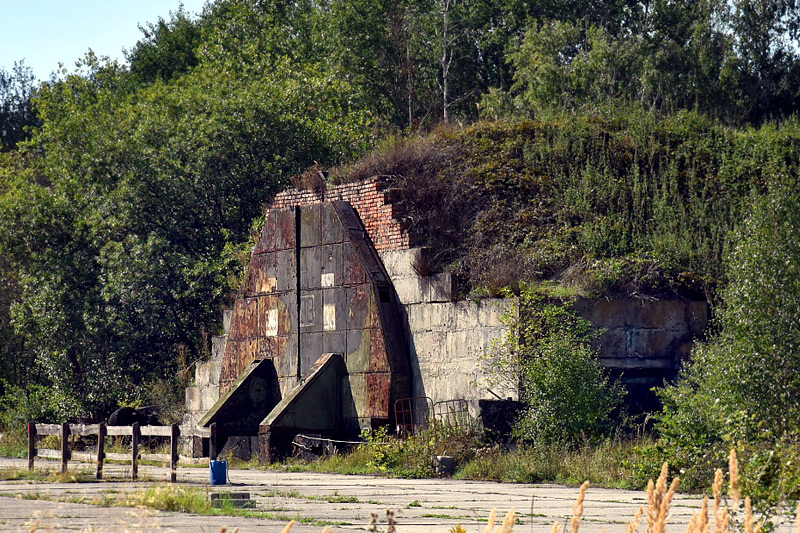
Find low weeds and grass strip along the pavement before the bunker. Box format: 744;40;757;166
270;428;648;490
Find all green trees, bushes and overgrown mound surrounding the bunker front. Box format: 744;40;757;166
0;0;800;516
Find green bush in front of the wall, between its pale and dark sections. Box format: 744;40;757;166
491;286;624;445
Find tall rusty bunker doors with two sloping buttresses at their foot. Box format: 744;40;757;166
199;201;411;460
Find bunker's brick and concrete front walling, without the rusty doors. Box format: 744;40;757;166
186;178;708;430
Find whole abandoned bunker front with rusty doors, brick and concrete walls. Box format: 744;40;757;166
184;177;708;461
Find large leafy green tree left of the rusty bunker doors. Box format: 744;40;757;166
0;40;372;414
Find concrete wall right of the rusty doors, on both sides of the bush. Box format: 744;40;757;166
380;248;708;414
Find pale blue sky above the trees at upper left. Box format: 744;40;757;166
0;0;205;79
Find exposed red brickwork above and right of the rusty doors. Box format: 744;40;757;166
270;177;413;252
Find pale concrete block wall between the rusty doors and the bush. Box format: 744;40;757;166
380;248;516;415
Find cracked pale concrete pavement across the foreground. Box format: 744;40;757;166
0;459;796;533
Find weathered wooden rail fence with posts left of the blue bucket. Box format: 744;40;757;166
28;422;217;483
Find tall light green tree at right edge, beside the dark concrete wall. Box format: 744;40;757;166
659;182;800;474
